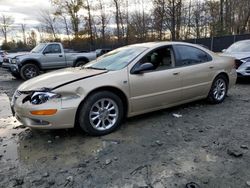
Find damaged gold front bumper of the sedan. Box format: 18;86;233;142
11;91;76;129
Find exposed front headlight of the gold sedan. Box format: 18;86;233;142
30;92;61;105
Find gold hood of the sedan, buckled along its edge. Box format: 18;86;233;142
18;68;108;91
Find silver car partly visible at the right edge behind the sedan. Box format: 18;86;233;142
222;40;250;77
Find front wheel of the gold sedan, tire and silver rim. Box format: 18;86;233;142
78;91;124;136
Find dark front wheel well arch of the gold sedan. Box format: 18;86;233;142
75;87;128;128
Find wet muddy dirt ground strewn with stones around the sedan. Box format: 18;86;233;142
0;68;250;188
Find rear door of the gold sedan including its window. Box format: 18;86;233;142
174;44;215;101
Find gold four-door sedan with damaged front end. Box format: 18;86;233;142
11;42;237;135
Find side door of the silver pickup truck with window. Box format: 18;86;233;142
41;44;66;69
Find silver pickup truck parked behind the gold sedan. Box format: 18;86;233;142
8;42;96;80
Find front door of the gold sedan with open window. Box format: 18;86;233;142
129;46;181;114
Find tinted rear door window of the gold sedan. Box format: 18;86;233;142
174;45;212;67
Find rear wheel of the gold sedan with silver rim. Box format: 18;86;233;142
208;75;228;104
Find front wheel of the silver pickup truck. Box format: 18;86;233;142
20;64;40;80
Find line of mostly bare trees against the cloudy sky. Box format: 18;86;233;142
0;0;250;49
